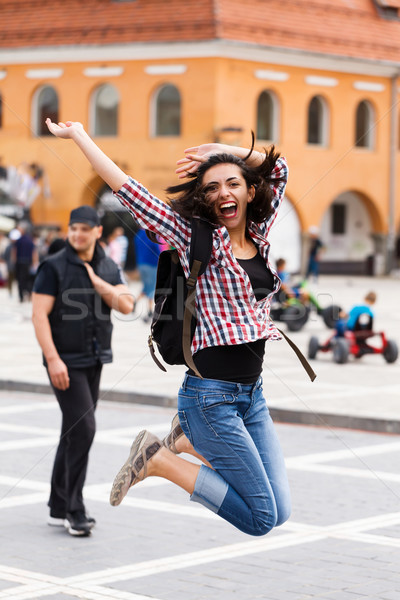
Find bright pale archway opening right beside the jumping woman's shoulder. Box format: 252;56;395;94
268;196;302;273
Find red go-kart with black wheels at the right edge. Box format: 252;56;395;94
308;315;399;364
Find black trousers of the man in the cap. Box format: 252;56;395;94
48;364;102;518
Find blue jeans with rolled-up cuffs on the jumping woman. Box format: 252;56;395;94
178;375;291;535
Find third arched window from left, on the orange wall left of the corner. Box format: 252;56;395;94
153;84;181;136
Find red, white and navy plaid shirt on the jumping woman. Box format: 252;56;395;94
115;157;288;354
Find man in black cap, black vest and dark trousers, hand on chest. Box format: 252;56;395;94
32;206;134;536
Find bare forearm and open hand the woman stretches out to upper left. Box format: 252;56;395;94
46;119;128;192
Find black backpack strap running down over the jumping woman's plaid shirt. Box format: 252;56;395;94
182;217;213;379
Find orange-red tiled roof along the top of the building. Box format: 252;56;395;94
0;0;400;63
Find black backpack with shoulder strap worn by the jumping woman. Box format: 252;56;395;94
148;217;213;377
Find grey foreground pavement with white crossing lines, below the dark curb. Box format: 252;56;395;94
0;391;400;600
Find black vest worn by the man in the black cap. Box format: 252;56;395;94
39;242;120;368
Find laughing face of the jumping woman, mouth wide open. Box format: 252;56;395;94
202;163;254;230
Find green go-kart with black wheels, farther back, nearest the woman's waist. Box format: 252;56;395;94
271;282;341;331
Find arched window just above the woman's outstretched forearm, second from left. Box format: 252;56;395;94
90;83;119;136
